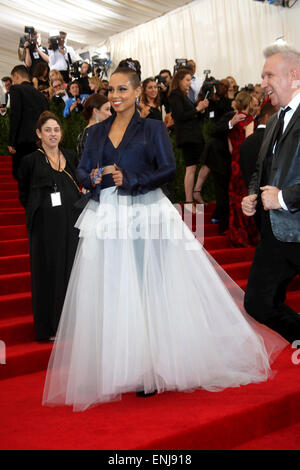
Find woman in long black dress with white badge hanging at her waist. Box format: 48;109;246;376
19;111;80;341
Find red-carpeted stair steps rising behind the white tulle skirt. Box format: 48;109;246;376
0;157;300;379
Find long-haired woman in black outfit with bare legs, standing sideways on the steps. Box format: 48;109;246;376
169;69;209;203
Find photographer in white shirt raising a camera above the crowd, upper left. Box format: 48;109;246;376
48;31;76;83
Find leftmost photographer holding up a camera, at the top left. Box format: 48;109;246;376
19;26;49;78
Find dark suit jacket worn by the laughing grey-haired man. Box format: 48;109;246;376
249;105;300;243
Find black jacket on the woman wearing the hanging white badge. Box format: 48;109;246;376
18;149;77;234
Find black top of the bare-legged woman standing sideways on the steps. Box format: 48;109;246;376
169;90;204;147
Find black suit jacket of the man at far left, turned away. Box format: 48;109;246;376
8;82;49;147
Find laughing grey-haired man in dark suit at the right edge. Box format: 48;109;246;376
242;45;300;343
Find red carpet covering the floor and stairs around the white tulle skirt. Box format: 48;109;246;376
0;153;300;449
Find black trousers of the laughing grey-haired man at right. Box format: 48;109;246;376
245;213;300;343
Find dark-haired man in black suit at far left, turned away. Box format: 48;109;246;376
8;65;49;179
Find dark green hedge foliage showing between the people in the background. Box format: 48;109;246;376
0;103;215;202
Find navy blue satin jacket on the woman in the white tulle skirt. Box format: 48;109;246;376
76;111;176;201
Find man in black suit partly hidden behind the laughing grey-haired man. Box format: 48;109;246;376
240;103;278;187
